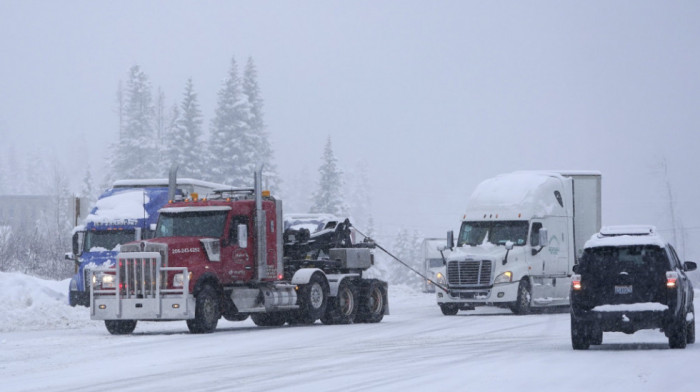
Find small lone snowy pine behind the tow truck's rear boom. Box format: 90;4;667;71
310;136;348;218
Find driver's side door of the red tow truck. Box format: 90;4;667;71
221;215;255;282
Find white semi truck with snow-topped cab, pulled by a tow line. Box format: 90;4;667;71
436;171;601;315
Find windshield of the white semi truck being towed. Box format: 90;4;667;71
457;221;528;246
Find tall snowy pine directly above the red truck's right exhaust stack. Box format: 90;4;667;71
241;57;280;194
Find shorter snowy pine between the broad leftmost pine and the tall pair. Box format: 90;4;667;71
165;78;204;178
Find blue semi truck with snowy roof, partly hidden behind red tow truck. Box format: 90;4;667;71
65;178;230;306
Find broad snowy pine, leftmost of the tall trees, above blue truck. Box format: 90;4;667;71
109;65;162;179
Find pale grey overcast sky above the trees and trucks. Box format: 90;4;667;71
0;0;700;260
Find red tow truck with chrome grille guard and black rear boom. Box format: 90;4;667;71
90;170;389;334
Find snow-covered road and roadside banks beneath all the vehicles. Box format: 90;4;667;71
0;273;700;392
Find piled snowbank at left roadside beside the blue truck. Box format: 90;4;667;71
0;272;95;332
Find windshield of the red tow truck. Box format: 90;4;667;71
156;211;226;238
